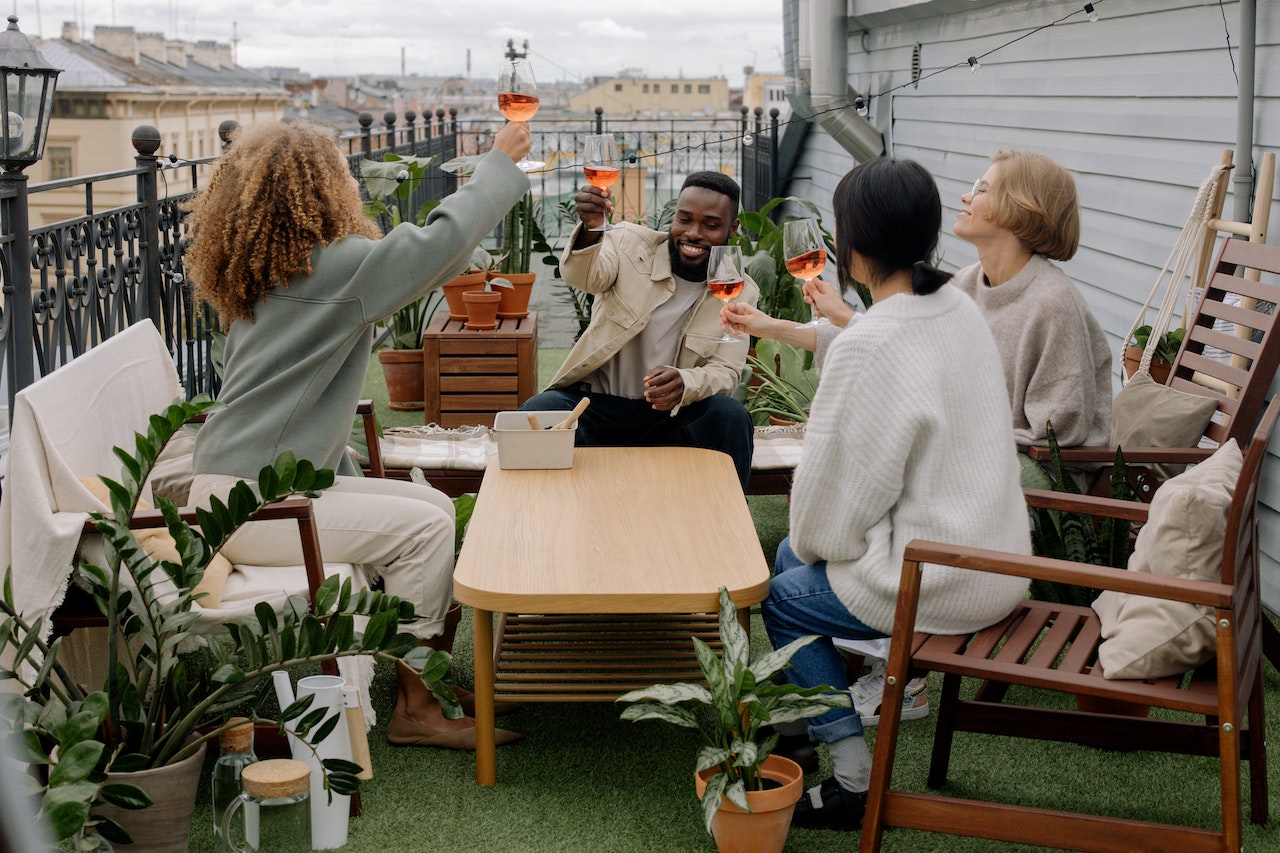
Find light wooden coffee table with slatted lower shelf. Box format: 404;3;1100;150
453;447;769;785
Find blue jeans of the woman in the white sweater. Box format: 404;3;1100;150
762;537;884;743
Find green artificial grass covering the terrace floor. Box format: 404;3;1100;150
172;350;1280;853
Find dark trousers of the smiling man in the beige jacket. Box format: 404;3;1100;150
520;384;755;492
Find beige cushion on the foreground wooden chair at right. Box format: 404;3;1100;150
1093;438;1244;679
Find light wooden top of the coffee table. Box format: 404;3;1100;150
453;447;769;613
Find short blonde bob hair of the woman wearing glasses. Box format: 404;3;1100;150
991;150;1080;261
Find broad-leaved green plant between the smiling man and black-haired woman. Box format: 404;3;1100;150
730;196;872;346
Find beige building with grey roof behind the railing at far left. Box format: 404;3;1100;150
27;23;289;225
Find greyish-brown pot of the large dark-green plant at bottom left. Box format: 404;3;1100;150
96;744;207;853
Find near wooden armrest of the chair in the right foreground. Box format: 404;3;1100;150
902;539;1233;608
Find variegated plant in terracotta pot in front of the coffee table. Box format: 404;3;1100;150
617;587;852;853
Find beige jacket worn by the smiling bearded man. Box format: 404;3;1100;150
549;223;760;406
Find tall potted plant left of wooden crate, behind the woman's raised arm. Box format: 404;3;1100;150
360;154;448;411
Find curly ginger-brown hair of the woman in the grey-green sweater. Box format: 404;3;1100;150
184;122;381;329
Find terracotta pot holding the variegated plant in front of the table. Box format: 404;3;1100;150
694;756;804;853
